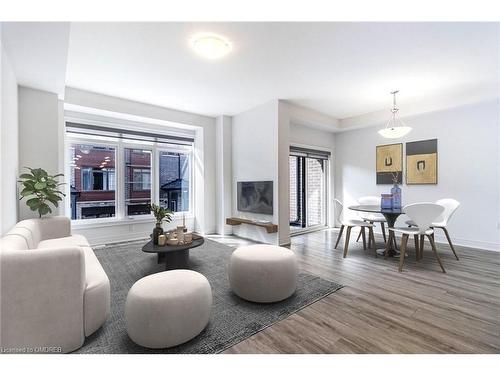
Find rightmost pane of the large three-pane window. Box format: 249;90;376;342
158;151;191;212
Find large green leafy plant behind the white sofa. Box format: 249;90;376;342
18;167;65;217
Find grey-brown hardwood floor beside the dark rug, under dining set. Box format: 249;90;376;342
214;230;500;353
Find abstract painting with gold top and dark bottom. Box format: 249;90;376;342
376;143;403;185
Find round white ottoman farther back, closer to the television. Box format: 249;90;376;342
229;245;297;302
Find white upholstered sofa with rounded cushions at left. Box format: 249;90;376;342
0;216;110;353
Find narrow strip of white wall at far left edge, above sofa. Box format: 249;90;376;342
0;31;19;234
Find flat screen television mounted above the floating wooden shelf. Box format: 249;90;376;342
238;181;273;215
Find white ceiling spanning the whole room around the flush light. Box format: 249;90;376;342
1;22;500;124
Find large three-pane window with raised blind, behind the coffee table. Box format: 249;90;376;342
66;122;194;220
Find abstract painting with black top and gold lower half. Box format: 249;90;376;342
406;139;437;185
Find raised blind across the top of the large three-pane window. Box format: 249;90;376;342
66;122;194;146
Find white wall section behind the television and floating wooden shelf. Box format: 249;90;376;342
232;100;279;244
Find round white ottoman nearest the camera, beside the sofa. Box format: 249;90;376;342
125;270;212;349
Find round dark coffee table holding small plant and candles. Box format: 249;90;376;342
142;236;205;271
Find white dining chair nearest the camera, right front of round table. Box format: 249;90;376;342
386;202;446;272
